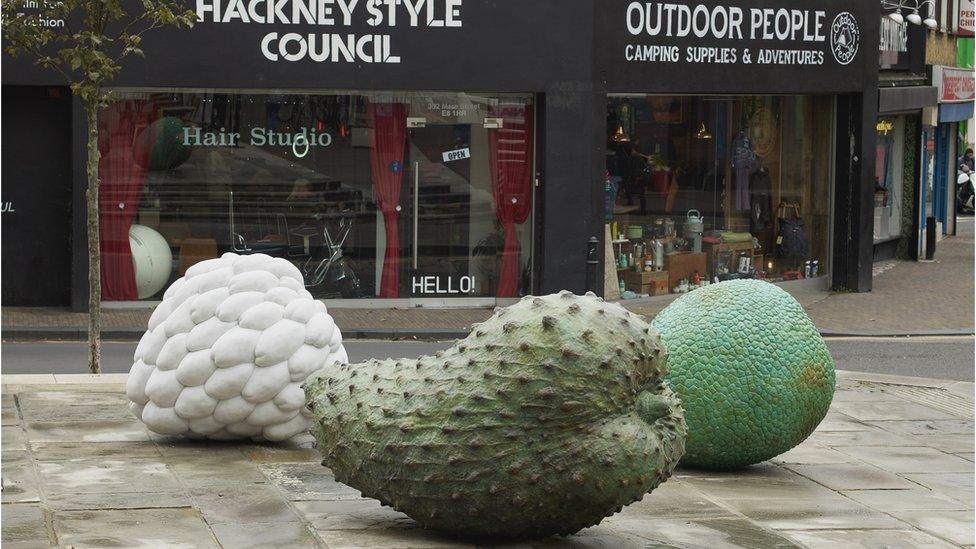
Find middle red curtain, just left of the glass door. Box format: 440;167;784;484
368;102;407;297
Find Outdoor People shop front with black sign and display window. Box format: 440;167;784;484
595;1;877;297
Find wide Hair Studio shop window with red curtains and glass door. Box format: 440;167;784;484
99;90;535;301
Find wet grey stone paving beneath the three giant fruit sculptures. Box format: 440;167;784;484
2;372;974;548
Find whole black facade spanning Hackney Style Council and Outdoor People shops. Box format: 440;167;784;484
2;0;878;309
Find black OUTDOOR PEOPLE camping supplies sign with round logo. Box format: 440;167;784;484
595;0;877;91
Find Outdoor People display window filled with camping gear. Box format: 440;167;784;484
605;95;833;294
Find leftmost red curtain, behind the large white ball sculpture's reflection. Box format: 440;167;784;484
98;101;156;301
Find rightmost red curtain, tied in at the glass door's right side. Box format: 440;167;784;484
489;103;533;297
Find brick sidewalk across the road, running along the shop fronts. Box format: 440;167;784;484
0;220;976;340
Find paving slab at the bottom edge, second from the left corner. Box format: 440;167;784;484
54;507;219;549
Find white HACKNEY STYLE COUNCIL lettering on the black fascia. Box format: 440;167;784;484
196;0;463;63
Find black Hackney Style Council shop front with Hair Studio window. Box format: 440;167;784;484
3;0;601;308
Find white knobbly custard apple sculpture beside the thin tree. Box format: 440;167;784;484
126;253;348;440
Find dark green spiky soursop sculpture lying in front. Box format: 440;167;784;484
305;292;686;538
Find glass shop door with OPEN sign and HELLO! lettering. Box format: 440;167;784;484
402;96;534;298
